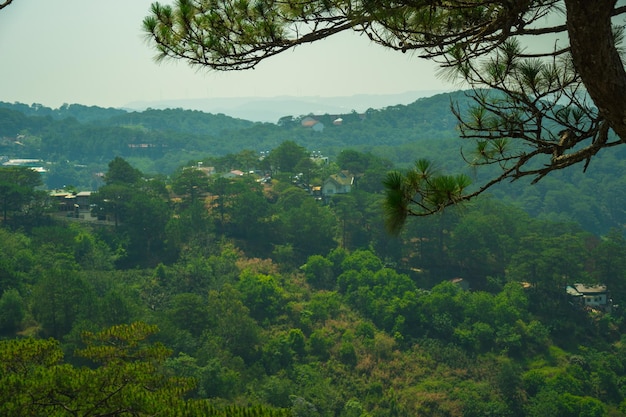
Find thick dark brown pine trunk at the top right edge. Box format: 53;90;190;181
565;0;626;142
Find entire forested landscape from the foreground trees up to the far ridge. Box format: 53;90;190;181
0;96;626;417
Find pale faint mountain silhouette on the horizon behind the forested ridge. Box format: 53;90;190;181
125;90;442;123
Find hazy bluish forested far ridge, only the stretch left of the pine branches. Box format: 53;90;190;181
0;94;458;167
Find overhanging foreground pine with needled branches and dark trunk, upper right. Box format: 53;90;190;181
144;0;626;230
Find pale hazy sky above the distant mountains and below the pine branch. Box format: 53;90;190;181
0;0;452;107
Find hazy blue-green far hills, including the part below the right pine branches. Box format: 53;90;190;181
0;92;626;235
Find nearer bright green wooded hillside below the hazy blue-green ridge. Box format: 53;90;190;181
0;151;626;417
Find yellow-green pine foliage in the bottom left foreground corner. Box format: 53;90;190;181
0;323;285;417
